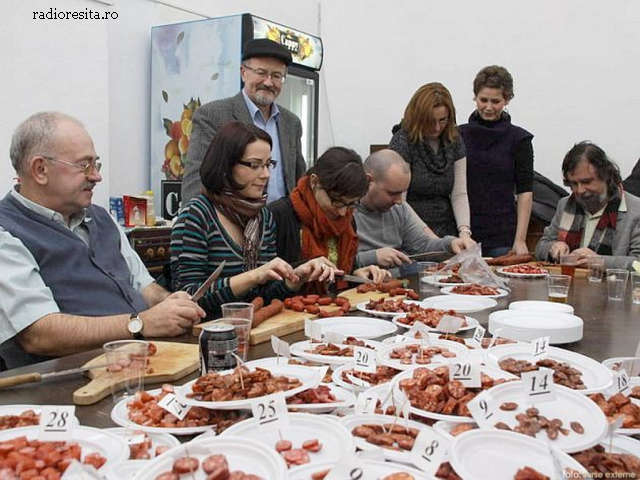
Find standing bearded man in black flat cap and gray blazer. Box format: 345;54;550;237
182;38;307;205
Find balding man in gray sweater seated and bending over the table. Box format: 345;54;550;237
354;149;464;268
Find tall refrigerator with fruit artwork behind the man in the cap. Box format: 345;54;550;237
149;13;324;219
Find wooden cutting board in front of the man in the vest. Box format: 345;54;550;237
73;342;200;405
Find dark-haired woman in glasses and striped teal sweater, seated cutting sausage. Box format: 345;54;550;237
171;122;334;318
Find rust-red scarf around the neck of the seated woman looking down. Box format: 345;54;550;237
290;176;358;288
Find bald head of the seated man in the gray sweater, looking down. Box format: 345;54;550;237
362;149;411;212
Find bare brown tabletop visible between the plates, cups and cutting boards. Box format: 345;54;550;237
0;277;640;427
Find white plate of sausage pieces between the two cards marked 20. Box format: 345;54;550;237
377;339;469;370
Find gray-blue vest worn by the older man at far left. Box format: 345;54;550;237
0;195;147;368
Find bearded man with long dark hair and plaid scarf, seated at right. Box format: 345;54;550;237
536;142;640;270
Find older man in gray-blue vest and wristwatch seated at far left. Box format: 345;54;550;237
0;112;205;368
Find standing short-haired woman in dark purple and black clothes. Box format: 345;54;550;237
460;65;533;257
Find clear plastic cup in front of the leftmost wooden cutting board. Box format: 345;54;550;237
102;340;149;402
